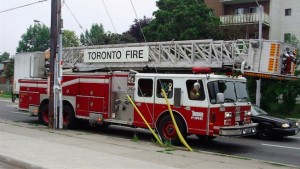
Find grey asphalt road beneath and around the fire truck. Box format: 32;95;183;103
0;98;300;167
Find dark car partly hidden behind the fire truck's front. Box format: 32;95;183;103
251;105;299;139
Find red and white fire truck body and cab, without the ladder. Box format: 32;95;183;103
19;72;256;142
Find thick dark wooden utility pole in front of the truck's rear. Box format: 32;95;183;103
48;0;58;129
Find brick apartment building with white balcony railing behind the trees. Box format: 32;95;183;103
204;0;300;42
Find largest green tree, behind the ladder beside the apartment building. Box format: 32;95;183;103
144;0;220;41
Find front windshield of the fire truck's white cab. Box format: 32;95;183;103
207;81;249;104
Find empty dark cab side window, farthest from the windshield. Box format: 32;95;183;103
137;79;153;97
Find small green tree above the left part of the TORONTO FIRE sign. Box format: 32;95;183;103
80;24;105;46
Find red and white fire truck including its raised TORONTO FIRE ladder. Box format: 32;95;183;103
19;40;298;143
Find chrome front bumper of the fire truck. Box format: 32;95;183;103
219;123;258;137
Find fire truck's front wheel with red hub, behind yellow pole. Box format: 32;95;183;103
158;115;187;145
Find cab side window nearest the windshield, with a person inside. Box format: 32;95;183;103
186;80;205;100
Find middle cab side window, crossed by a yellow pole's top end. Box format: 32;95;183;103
156;79;173;99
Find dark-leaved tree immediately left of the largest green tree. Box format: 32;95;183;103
125;16;152;42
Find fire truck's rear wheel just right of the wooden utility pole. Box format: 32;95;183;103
63;105;76;129
